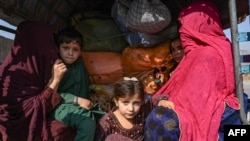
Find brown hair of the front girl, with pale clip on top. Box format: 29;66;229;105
112;77;144;104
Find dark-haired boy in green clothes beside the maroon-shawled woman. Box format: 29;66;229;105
52;28;105;141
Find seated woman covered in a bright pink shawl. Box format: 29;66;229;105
145;0;240;141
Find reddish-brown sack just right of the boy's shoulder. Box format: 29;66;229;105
82;52;123;85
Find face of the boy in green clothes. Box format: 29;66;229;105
59;41;81;65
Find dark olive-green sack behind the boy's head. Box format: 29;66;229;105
75;19;128;53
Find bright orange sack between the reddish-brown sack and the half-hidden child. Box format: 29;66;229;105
122;41;175;94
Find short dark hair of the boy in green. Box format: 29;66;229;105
56;28;84;49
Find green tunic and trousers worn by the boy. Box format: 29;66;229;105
52;58;105;141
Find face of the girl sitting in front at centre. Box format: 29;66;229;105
115;94;142;120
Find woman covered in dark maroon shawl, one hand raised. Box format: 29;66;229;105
0;21;66;141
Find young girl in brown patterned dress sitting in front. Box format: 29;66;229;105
95;77;148;141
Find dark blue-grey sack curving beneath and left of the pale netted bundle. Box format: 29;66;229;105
111;0;178;47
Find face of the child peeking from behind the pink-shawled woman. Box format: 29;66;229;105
171;39;184;63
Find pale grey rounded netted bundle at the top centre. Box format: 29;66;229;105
113;0;171;34
